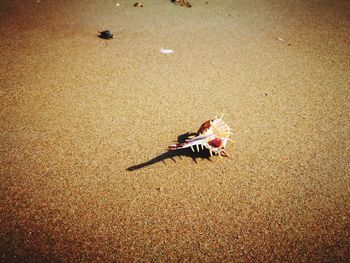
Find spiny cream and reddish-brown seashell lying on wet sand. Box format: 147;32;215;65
168;116;232;157
